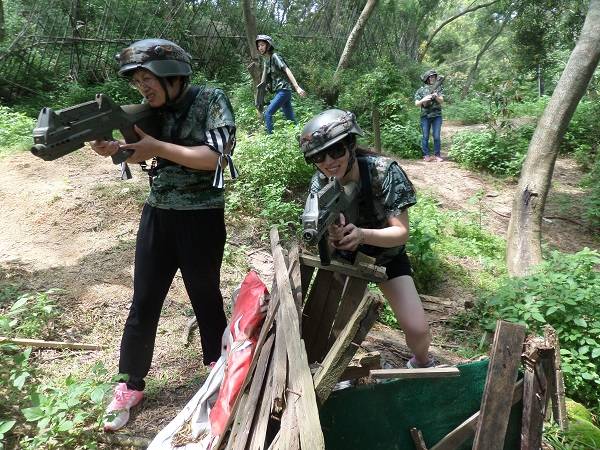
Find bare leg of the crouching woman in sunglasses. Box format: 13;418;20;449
379;275;431;365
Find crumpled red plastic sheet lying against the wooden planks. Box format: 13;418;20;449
210;271;269;436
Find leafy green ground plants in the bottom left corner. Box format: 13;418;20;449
0;287;111;450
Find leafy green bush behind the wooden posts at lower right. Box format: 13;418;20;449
487;249;600;404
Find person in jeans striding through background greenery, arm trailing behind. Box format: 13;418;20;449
256;34;306;134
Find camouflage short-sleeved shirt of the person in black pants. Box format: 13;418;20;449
147;86;235;209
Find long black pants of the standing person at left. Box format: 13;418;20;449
119;205;227;390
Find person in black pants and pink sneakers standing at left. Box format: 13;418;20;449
91;39;237;431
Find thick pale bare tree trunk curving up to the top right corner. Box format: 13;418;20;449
506;0;600;276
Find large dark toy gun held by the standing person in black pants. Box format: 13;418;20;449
31;94;158;179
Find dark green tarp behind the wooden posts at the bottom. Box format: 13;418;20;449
320;360;522;450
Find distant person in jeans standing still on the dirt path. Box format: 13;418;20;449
415;69;444;162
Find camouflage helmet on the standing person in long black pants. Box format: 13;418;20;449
116;39;192;77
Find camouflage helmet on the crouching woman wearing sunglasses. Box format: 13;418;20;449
299;109;363;158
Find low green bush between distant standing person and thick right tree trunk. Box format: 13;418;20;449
450;126;533;176
